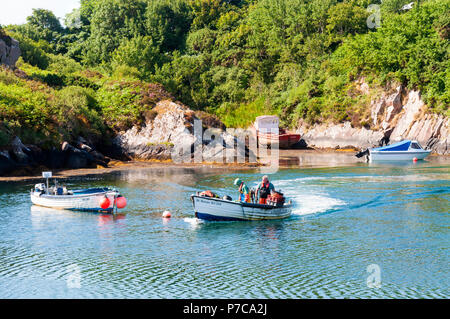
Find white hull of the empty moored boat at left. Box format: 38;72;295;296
30;191;119;212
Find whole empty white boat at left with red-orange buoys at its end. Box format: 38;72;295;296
30;172;127;213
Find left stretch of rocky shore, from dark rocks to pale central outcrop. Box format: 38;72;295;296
0;100;257;176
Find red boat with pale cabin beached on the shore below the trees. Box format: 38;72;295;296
253;115;300;149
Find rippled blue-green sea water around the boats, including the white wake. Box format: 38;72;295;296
0;161;450;298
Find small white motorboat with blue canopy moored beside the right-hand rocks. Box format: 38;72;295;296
356;140;431;162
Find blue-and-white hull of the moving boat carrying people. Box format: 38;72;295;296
191;193;292;221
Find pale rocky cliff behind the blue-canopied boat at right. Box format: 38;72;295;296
297;85;450;155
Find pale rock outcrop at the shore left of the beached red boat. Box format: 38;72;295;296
113;100;253;162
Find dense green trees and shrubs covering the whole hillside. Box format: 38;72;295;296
0;0;450;150
